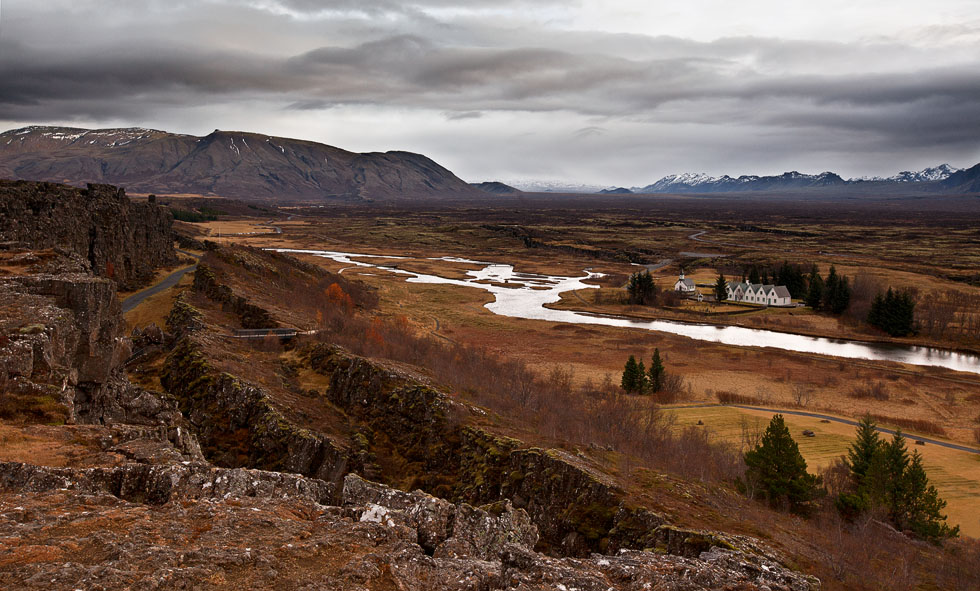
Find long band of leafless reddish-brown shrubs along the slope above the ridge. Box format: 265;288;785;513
317;307;743;481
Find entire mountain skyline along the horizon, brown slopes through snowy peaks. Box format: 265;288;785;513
0;126;980;202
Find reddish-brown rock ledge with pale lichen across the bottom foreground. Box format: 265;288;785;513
0;463;819;591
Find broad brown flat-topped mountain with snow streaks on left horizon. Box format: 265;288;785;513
0;126;485;201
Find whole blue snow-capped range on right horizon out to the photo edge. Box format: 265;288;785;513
617;164;976;193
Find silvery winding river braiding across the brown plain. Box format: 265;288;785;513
276;249;980;374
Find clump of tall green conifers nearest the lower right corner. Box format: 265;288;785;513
836;417;959;541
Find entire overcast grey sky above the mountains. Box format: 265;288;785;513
0;0;980;186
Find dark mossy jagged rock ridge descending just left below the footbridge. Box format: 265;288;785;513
160;337;347;482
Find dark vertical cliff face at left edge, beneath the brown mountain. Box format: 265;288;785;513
0;181;177;290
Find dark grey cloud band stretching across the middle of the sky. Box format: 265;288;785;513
7;24;980;146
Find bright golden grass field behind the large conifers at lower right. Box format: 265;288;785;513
667;406;980;537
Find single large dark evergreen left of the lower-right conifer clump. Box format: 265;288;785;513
745;414;820;512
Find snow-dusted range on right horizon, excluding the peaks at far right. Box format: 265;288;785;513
633;170;847;193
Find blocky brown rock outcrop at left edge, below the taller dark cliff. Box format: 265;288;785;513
0;274;184;434
